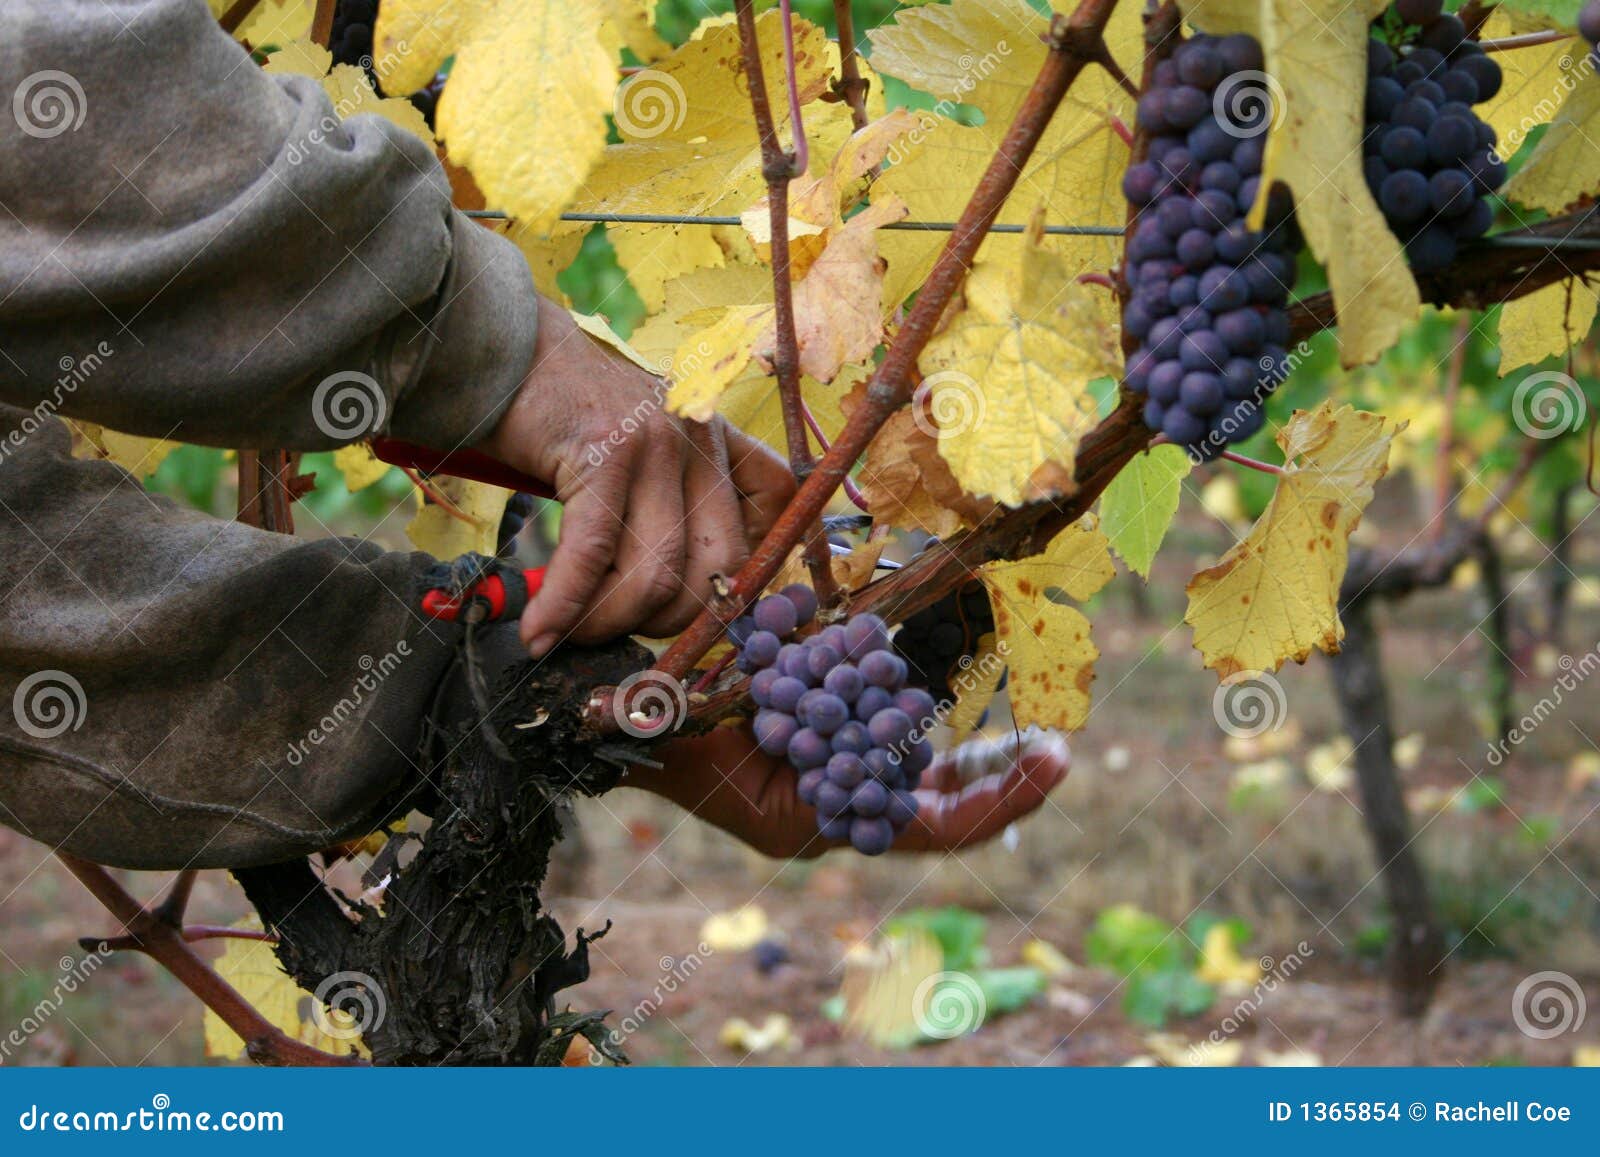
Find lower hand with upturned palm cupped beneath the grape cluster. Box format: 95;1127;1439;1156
622;725;1072;859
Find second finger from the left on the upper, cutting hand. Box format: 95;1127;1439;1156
571;427;688;643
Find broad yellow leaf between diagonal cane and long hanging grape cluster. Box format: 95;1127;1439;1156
918;219;1122;506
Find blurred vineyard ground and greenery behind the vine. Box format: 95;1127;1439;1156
0;0;1600;1064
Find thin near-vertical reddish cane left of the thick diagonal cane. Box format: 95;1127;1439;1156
732;0;838;611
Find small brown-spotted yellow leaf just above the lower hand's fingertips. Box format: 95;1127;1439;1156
981;517;1117;731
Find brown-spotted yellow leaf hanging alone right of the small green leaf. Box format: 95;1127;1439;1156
1184;402;1395;679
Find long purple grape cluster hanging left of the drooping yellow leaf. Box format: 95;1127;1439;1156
1122;35;1301;461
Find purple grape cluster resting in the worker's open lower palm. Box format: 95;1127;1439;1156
728;583;936;856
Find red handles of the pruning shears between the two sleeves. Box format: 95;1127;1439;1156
371;438;555;623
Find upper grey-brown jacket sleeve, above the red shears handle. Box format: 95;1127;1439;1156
0;0;538;450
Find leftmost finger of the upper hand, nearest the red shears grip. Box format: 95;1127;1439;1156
522;448;632;658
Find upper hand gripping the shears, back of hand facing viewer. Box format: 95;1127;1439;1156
478;299;794;658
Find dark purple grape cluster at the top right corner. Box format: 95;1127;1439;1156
1363;0;1506;274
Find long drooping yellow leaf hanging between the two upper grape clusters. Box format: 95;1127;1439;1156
1181;0;1422;366
